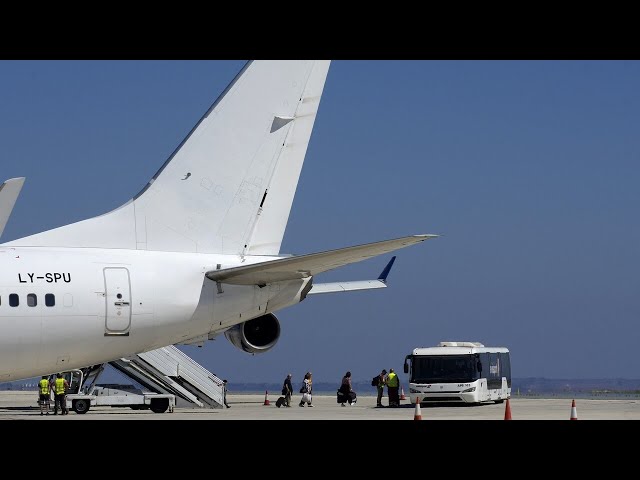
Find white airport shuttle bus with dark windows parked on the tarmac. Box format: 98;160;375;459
404;342;511;405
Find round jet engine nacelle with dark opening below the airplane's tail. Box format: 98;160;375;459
224;313;280;353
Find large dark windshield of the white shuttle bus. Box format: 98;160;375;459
410;354;478;383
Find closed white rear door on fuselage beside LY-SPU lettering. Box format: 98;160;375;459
104;267;131;336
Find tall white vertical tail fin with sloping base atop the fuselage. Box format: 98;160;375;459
6;60;330;255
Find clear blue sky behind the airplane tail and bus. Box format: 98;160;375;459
0;60;640;383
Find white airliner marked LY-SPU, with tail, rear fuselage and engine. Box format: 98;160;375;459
0;60;436;382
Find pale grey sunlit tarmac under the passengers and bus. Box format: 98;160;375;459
0;391;640;421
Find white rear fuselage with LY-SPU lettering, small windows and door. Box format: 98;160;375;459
0;247;311;382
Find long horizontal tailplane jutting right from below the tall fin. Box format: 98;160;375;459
206;235;438;286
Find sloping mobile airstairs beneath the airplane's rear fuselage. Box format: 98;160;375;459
70;345;224;408
